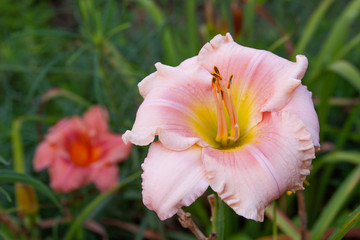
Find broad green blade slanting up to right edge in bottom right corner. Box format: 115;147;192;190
311;166;360;239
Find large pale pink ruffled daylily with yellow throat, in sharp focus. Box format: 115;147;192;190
123;33;319;221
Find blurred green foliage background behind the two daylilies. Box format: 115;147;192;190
0;0;360;240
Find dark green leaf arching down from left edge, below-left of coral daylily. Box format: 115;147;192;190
0;170;62;210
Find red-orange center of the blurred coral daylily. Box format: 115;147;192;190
68;140;100;167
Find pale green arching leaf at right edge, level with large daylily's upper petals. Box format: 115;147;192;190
329;60;360;92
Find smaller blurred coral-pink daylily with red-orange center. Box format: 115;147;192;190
34;106;132;193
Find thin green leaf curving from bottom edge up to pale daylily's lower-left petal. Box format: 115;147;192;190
64;172;141;240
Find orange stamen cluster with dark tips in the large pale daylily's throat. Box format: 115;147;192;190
211;66;240;145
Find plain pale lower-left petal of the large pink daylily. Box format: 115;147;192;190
142;143;209;220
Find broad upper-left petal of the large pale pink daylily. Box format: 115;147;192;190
123;57;216;150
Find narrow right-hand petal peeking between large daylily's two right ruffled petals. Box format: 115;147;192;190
282;85;320;149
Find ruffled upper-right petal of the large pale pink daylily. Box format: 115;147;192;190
199;33;308;129
